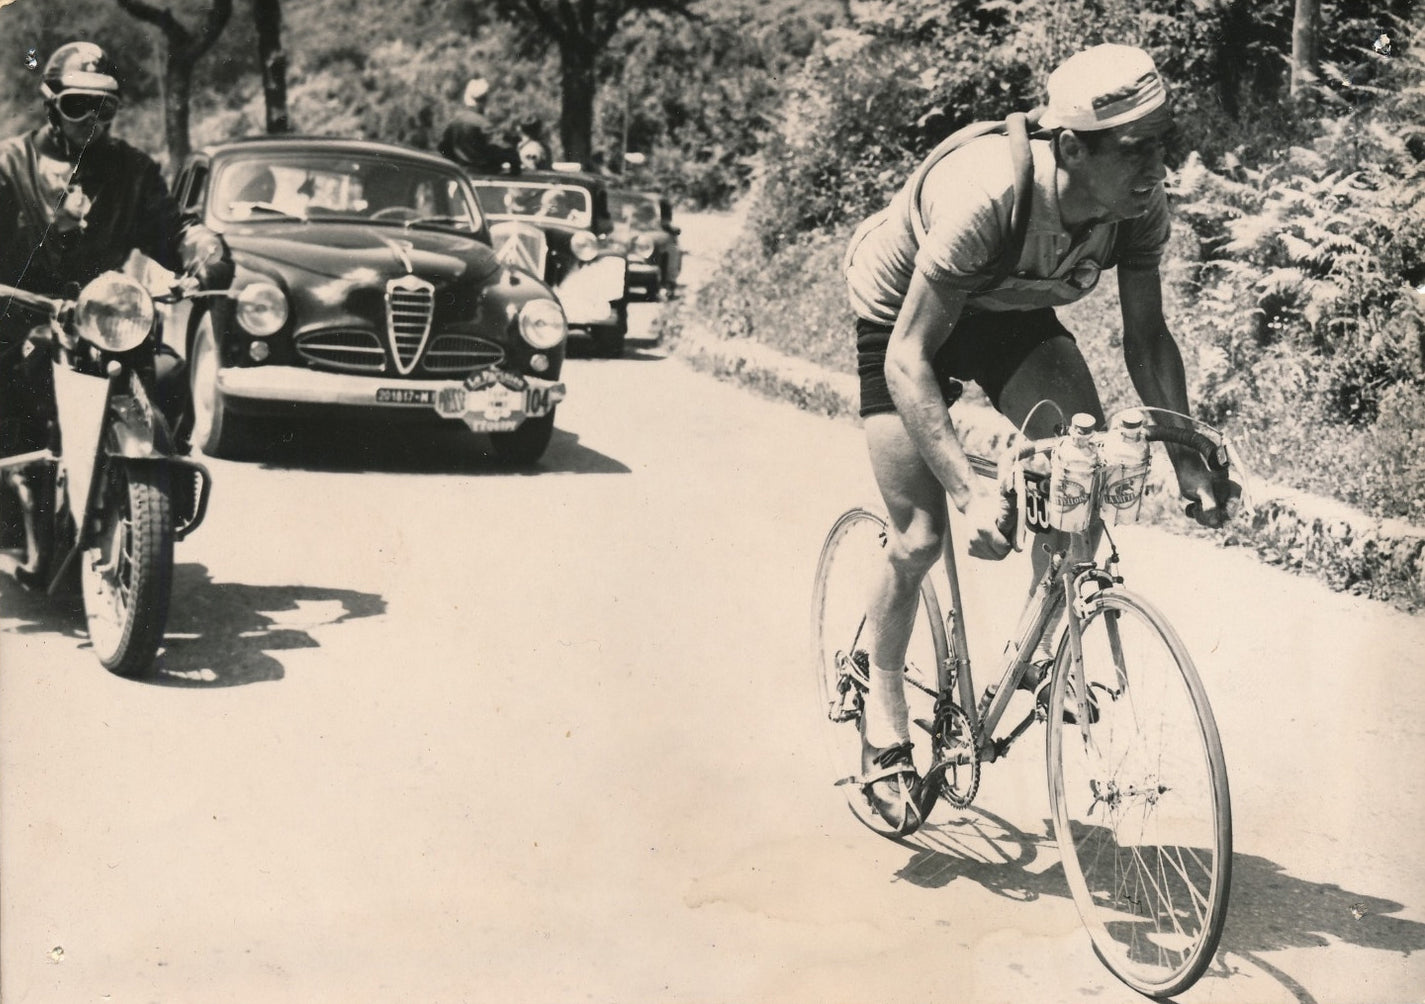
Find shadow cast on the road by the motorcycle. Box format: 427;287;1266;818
144;564;386;688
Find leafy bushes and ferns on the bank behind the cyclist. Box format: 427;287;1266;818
697;0;1425;523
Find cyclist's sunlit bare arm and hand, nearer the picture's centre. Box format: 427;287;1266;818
886;271;1009;558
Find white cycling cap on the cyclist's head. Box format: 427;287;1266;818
1039;46;1167;131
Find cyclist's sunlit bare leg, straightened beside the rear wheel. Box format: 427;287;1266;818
864;412;949;748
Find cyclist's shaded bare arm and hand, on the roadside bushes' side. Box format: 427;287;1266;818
1119;262;1217;525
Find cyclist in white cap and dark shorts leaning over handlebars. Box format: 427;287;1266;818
845;46;1220;827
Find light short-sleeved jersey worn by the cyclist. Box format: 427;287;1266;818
844;135;1169;325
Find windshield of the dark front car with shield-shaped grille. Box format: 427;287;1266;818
212;151;482;232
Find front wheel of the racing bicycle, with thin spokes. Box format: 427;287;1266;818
1049;590;1233;997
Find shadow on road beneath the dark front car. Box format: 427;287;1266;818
242;422;628;477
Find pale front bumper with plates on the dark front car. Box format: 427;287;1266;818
218;366;564;432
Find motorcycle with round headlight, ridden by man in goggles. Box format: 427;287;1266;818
0;272;211;676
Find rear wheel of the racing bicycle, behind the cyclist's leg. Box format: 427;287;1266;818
811;508;946;836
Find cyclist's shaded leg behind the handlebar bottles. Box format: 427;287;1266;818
999;336;1103;661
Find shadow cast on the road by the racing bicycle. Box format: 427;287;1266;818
896;809;1425;1004
